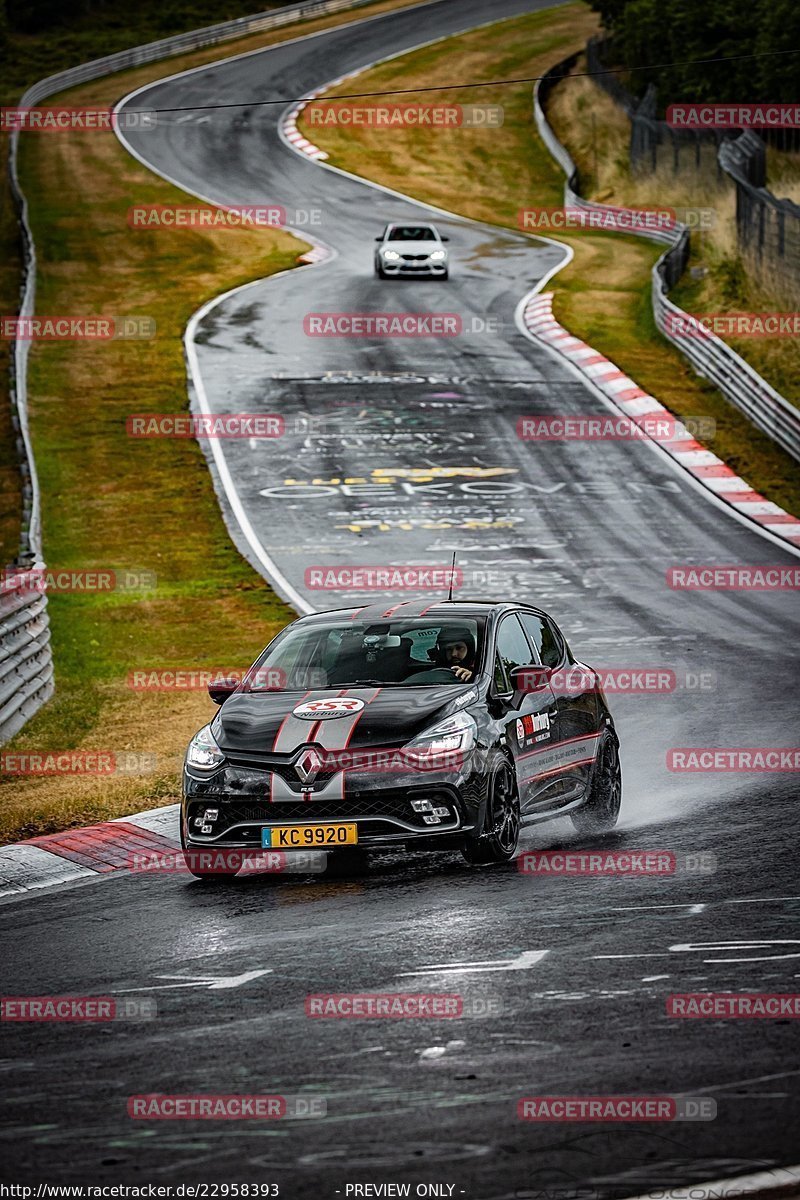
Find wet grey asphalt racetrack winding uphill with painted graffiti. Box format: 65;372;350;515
0;0;800;1200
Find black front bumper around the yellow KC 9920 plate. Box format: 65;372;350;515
181;756;483;851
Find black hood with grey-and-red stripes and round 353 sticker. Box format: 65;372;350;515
213;684;469;754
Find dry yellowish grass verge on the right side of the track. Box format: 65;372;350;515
300;4;800;512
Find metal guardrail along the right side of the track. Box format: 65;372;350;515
534;54;800;461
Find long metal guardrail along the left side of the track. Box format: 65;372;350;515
0;0;381;745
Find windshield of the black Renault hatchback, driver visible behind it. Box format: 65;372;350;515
243;617;485;691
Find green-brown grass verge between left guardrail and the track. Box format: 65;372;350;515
0;2;422;842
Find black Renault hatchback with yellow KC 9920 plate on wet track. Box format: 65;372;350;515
181;601;621;876
